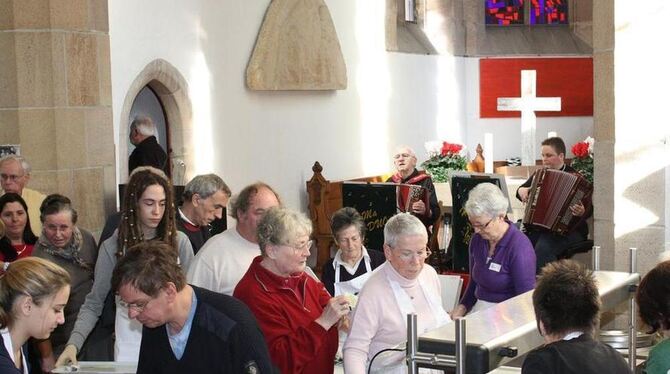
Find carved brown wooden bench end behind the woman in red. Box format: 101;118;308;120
307;161;383;276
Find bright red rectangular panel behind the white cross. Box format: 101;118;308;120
479;57;593;118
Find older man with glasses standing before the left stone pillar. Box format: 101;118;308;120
0;155;46;236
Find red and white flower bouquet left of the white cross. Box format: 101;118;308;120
421;141;467;183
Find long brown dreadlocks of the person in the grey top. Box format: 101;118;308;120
116;166;178;258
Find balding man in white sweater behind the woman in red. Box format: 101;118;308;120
187;182;280;296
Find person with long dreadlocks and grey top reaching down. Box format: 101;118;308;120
56;167;193;367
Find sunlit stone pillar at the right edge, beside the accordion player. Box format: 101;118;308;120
593;0;670;273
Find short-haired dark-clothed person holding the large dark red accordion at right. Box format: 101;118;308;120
516;137;593;273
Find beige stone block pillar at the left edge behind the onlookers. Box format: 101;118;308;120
0;0;116;232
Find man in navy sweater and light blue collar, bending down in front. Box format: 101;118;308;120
112;241;275;374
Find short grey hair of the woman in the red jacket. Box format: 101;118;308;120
256;207;312;256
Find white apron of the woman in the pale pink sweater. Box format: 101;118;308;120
366;264;451;374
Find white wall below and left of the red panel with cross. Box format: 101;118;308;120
465;58;593;161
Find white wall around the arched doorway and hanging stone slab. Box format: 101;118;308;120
109;0;468;210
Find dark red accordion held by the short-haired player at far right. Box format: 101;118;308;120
523;169;593;234
